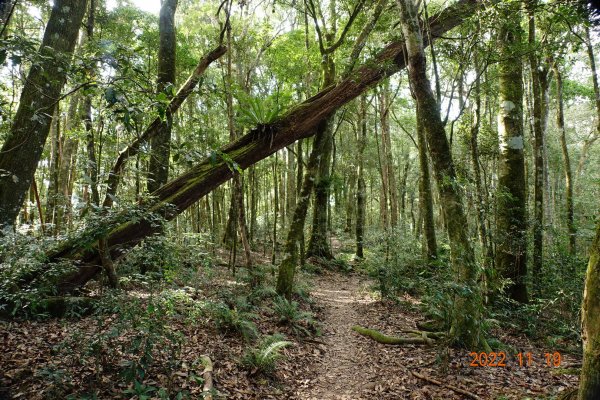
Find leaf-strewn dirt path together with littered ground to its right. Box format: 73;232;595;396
295;272;577;400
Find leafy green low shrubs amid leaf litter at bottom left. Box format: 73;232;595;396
49;292;187;399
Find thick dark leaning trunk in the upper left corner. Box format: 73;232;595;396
0;0;87;231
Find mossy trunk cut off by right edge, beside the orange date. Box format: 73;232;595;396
577;220;600;400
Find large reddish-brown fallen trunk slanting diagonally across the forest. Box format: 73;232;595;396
48;0;483;293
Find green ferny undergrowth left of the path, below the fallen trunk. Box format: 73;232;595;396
0;230;320;399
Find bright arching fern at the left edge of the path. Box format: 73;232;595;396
241;334;292;375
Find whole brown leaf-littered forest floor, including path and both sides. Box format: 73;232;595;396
0;247;580;400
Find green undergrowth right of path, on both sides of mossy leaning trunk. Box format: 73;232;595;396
356;228;586;352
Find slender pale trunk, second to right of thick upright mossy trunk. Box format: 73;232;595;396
554;64;577;257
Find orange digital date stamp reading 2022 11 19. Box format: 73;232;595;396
469;351;561;368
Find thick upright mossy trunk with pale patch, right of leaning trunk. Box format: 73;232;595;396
496;3;528;303
